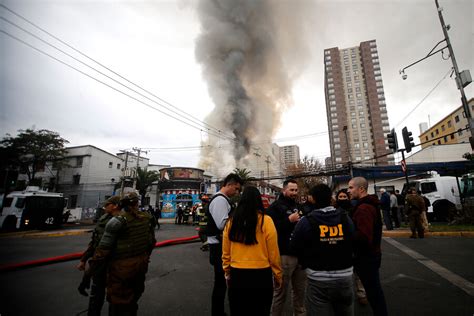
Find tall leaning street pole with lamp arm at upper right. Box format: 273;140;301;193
400;0;474;149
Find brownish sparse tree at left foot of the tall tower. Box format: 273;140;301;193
286;156;326;195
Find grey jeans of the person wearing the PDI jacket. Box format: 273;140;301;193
306;276;354;316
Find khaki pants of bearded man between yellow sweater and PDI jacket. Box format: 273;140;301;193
272;255;307;316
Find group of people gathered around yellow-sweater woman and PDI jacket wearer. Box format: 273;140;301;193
207;174;426;315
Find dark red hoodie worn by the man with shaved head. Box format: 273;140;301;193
352;195;382;258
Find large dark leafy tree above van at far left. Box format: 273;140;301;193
0;129;69;183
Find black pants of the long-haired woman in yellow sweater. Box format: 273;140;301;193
229;268;273;316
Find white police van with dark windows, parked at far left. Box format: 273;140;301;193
0;186;67;230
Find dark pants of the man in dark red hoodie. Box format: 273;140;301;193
354;255;387;316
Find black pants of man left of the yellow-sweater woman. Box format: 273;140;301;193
209;244;227;316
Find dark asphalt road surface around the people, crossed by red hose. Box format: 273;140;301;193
0;224;474;316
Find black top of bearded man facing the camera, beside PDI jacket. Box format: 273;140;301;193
267;194;298;256
